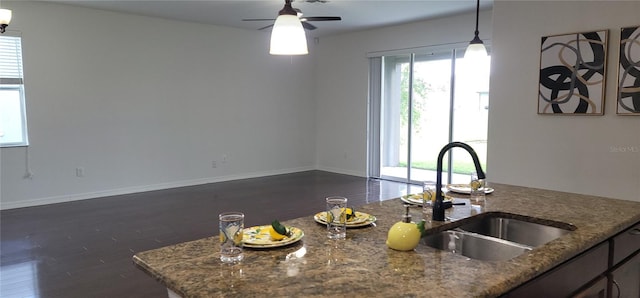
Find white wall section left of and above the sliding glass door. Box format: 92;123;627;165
316;11;491;176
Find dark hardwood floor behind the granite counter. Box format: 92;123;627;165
0;171;419;297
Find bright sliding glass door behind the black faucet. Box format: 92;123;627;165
369;45;490;183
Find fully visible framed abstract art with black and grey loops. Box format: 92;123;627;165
538;30;609;115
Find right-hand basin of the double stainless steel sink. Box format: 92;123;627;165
459;216;575;247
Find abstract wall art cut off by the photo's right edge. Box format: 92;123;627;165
616;26;640;115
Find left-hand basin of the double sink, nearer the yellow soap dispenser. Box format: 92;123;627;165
423;230;531;261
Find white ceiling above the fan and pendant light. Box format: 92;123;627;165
47;0;493;37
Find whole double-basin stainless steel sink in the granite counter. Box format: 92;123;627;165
423;213;576;261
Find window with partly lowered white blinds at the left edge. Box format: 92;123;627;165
0;35;28;147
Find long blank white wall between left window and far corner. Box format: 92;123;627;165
0;1;316;209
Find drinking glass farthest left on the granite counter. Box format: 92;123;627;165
218;212;244;263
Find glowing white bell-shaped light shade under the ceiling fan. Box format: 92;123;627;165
269;0;309;55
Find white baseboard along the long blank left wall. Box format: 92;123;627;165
0;167;316;210
